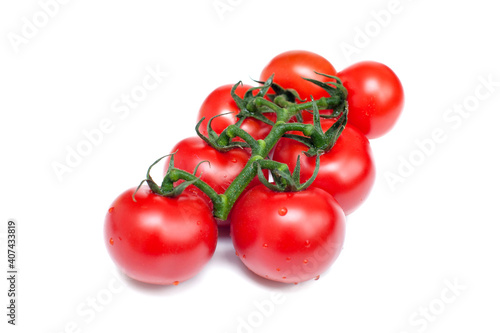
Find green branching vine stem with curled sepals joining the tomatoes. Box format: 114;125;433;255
145;73;348;220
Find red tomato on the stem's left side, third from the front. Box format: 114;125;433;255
197;84;276;141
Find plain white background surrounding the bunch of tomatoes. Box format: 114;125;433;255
0;0;500;333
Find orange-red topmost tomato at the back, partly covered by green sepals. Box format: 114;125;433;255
260;50;337;100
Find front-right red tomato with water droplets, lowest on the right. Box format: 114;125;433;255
230;185;345;283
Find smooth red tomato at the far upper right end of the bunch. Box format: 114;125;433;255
338;61;404;139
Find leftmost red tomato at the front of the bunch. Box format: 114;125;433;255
104;186;218;285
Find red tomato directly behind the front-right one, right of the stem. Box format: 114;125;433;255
273;119;375;215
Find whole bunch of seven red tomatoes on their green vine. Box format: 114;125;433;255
104;51;404;285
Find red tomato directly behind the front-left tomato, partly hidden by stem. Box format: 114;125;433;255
165;137;267;226
